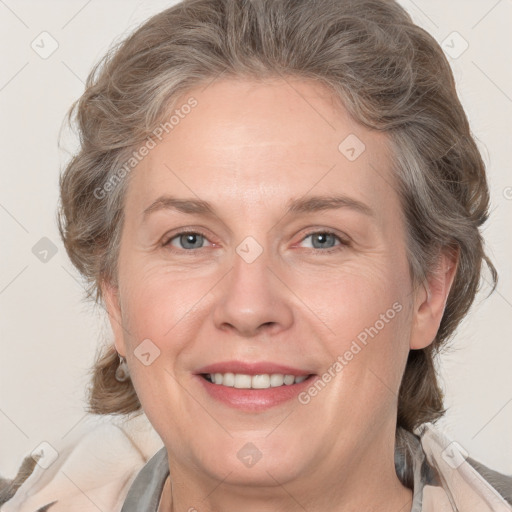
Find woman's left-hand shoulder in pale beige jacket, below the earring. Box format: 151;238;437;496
0;415;162;512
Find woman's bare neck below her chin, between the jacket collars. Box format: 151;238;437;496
158;433;412;512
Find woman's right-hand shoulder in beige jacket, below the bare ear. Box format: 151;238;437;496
416;423;512;512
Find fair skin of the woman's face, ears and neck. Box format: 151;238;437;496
102;79;456;512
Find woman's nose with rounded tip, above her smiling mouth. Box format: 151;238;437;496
213;243;293;338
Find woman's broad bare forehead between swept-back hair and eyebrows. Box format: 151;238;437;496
128;79;396;220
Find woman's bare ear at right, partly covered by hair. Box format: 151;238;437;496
410;249;459;350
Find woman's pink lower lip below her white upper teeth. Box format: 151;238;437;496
196;375;316;411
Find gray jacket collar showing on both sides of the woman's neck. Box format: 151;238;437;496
121;430;435;512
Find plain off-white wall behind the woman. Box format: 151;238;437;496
0;0;512;477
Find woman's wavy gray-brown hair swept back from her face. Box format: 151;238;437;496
58;0;498;431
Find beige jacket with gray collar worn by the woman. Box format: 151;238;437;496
0;415;512;512
